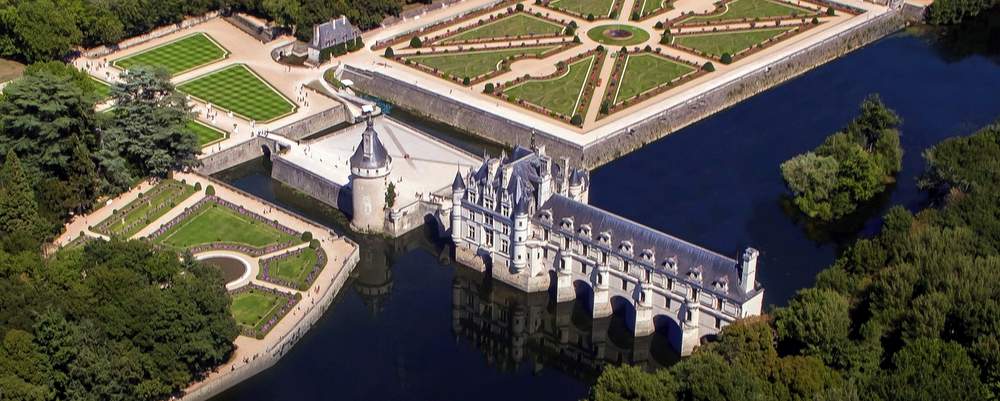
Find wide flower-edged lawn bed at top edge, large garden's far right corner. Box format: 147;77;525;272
668;0;820;26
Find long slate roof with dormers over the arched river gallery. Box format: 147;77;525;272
534;194;756;302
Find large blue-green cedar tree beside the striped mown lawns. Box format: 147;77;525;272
104;66;199;177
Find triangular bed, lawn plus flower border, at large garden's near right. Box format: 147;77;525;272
597;49;708;119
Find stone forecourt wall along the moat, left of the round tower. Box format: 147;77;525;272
271;155;353;214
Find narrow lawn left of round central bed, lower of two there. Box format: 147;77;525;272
406;46;559;78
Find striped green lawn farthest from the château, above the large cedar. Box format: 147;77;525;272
112;32;229;76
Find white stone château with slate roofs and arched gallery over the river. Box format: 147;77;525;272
450;147;764;355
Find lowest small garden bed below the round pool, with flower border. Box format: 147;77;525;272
229;284;302;340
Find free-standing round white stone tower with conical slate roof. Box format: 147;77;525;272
351;116;392;233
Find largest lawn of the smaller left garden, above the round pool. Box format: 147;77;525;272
157;202;298;249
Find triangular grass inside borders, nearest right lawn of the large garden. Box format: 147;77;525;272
614;54;694;104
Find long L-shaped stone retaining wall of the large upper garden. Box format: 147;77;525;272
343;10;906;169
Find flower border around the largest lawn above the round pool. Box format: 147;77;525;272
148;195;300;256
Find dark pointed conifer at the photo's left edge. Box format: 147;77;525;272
0;150;45;250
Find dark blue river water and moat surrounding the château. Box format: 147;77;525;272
209;19;1000;401
